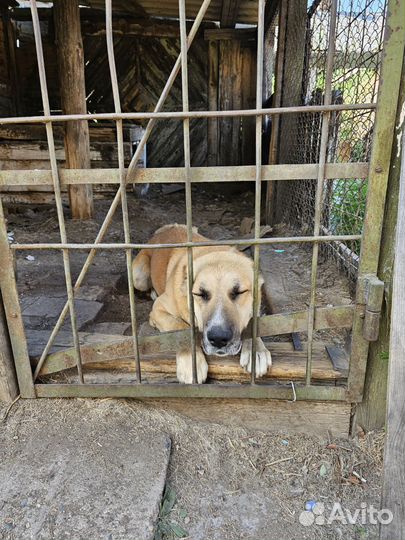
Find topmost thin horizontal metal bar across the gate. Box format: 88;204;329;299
0;101;377;125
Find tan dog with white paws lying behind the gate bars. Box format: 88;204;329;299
132;223;271;384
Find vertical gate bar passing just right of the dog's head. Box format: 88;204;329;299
251;0;266;384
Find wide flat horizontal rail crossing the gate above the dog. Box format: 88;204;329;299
0;163;368;188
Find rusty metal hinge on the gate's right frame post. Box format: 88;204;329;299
363;275;384;341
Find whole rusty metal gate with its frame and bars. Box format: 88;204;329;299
0;0;405;402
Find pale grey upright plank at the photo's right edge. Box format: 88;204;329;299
380;132;405;540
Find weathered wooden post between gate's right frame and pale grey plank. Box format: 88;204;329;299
354;54;405;431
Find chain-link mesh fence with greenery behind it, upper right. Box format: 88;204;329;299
282;0;386;278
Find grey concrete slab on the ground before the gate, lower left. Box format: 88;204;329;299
0;400;170;540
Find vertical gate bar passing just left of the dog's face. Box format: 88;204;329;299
179;0;197;384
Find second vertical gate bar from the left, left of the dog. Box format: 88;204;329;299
105;0;142;383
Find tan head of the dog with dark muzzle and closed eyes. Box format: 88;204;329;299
186;250;263;356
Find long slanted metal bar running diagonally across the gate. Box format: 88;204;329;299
34;0;211;380
